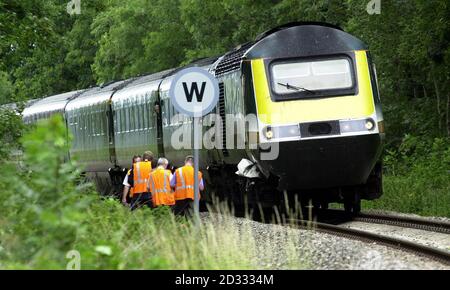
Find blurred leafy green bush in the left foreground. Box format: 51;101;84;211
0;117;89;268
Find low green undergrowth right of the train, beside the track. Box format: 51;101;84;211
364;135;450;217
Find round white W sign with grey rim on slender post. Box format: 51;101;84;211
169;67;219;222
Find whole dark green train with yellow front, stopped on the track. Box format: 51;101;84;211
22;22;385;213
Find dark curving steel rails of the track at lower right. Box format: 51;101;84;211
290;210;450;266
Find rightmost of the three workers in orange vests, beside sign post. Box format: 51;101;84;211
170;155;205;215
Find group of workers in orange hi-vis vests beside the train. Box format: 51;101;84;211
122;151;204;214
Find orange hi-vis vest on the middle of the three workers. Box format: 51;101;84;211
149;168;175;206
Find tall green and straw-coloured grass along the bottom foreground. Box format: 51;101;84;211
0;193;308;270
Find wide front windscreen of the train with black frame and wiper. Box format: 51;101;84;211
269;57;356;101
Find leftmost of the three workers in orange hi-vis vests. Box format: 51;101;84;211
128;151;153;210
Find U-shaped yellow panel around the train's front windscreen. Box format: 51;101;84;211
252;51;375;125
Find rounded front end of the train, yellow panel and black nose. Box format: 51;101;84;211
243;24;384;207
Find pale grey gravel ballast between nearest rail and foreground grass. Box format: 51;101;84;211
201;213;450;270
